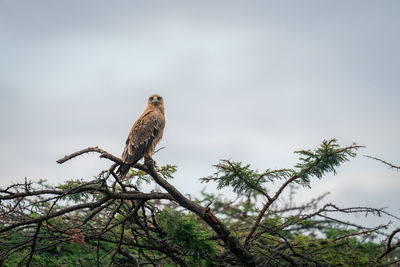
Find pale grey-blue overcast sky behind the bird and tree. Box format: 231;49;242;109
0;0;400;230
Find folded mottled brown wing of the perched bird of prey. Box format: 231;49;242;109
122;111;162;164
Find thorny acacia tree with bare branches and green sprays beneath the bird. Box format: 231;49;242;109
0;139;400;266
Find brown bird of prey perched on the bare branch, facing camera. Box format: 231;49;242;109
116;94;165;179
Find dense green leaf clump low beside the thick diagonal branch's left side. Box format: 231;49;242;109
159;209;215;266
